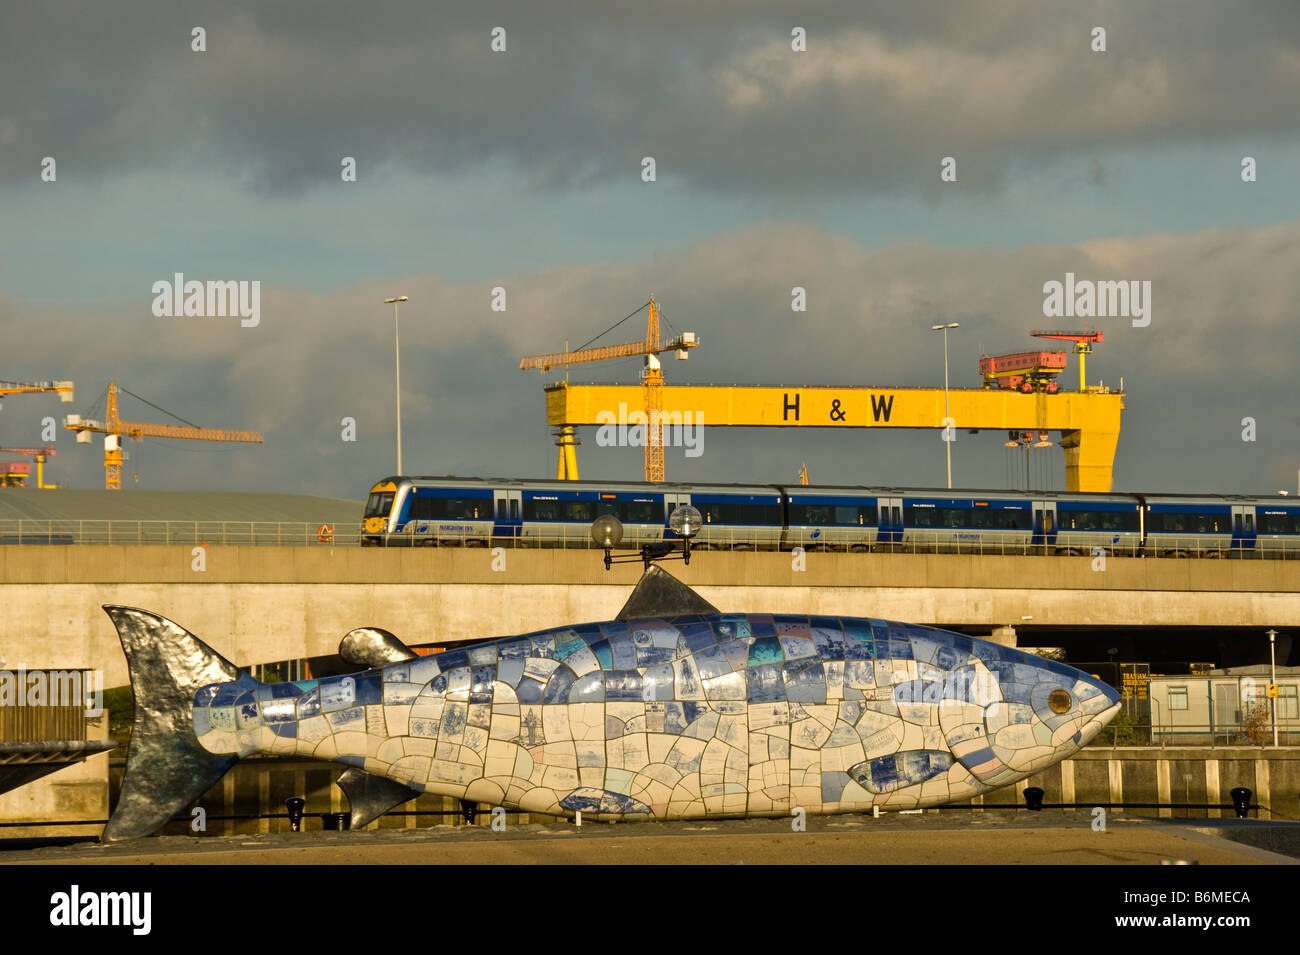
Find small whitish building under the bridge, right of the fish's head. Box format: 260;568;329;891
1149;664;1300;746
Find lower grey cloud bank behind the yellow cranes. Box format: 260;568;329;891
0;223;1300;496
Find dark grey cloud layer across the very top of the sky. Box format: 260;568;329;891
0;0;1300;194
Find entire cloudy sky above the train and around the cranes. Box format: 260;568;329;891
0;0;1300;498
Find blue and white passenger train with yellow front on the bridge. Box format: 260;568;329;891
361;477;1300;557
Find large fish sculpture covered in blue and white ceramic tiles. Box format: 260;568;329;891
104;567;1119;842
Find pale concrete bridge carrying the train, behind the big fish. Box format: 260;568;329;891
0;546;1300;686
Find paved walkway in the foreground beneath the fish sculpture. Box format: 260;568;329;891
0;812;1300;865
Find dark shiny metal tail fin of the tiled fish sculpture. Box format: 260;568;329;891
101;607;239;842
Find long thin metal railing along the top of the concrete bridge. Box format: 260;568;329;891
0;518;1300;559
